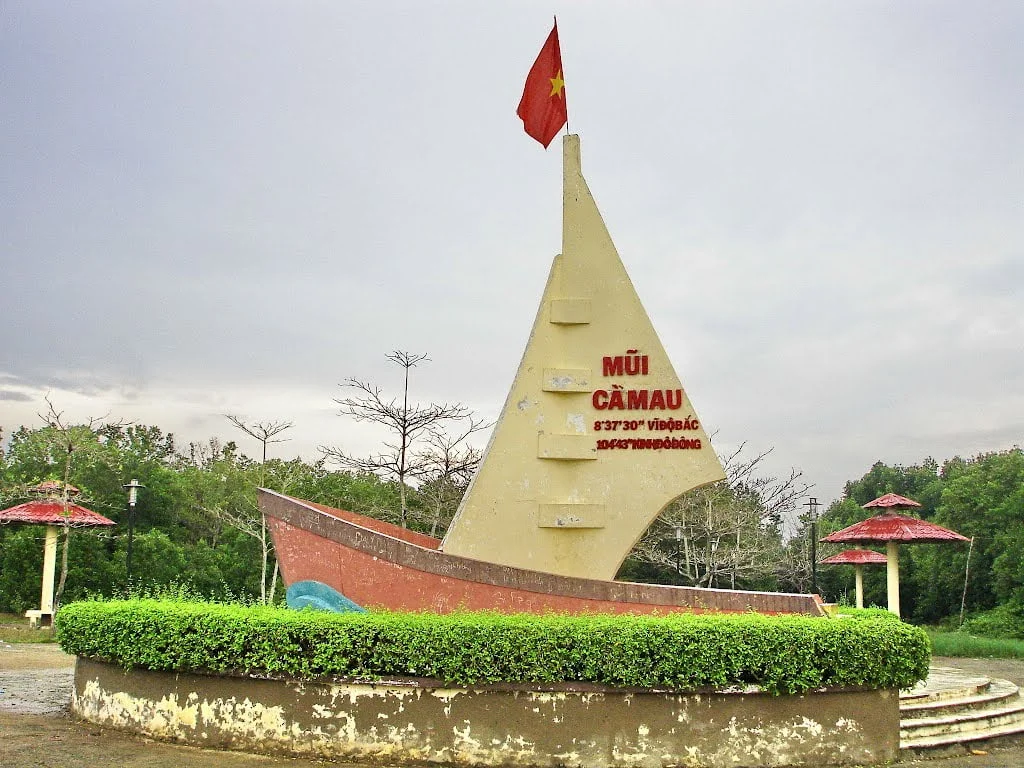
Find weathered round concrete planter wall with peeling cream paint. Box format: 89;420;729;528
72;658;899;768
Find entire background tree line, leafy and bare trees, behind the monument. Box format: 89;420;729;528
0;397;1024;624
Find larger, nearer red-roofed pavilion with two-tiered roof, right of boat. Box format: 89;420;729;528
821;494;968;615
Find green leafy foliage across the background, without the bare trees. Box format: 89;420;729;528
0;417;1024;637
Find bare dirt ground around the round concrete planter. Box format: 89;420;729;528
0;641;1024;768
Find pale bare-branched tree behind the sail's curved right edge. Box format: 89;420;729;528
632;443;811;589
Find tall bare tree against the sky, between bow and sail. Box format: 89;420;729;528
321;350;470;527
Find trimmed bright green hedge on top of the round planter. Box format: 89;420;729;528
56;600;930;693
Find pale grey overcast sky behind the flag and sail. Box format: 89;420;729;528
0;0;1024;514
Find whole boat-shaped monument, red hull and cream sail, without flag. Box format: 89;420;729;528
260;135;823;615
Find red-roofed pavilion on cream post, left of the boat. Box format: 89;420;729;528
0;481;114;625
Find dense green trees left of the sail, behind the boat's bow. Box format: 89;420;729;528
0;425;416;613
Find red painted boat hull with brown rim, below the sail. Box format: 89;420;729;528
260;490;823;615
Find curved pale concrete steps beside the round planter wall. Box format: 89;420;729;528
900;667;1024;752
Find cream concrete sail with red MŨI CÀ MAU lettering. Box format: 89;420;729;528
441;135;725;579
